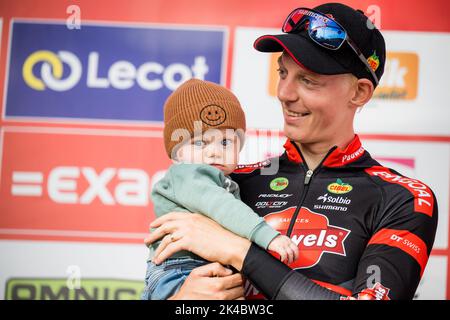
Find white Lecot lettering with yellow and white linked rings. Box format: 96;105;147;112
22;50;208;91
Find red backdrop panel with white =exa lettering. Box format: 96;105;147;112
0;127;170;243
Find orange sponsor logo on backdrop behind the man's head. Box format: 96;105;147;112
268;52;419;100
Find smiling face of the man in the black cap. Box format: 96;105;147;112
277;53;357;144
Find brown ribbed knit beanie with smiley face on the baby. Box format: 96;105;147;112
164;79;246;158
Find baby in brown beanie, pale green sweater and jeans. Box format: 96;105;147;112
142;79;298;300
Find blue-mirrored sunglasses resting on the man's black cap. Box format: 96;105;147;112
281;8;379;85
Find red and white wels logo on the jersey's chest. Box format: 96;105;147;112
265;207;351;269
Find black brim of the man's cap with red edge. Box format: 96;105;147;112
253;33;351;75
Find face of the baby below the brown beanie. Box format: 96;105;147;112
176;129;240;175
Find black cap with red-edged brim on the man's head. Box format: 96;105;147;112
253;3;386;87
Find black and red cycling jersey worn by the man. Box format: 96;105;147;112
232;135;438;299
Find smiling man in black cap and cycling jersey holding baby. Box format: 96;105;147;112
147;3;437;300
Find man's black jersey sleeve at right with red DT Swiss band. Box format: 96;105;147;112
353;186;438;299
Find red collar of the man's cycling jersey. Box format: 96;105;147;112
284;134;365;168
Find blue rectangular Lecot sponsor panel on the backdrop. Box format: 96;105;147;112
5;22;226;121
